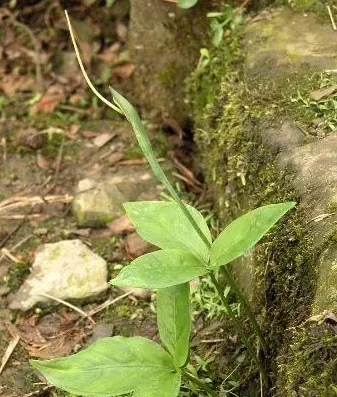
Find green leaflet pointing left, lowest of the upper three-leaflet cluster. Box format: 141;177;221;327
110;249;207;288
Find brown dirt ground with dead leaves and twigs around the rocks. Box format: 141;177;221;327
0;0;231;397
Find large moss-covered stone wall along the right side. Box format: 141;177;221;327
189;9;337;397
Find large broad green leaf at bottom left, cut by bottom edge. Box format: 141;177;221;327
31;336;180;397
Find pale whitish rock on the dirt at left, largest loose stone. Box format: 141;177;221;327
8;240;108;311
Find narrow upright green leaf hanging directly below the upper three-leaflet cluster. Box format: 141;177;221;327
157;283;191;367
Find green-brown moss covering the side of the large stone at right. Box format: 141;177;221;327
188;12;330;396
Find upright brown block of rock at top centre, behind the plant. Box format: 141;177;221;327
129;0;212;124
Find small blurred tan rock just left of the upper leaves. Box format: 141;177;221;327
72;179;127;227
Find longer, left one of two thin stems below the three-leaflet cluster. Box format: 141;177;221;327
210;272;268;386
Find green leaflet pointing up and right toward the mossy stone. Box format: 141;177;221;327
211;202;296;268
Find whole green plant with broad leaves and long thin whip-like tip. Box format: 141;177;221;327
31;10;295;397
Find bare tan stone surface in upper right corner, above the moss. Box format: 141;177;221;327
245;9;336;79
